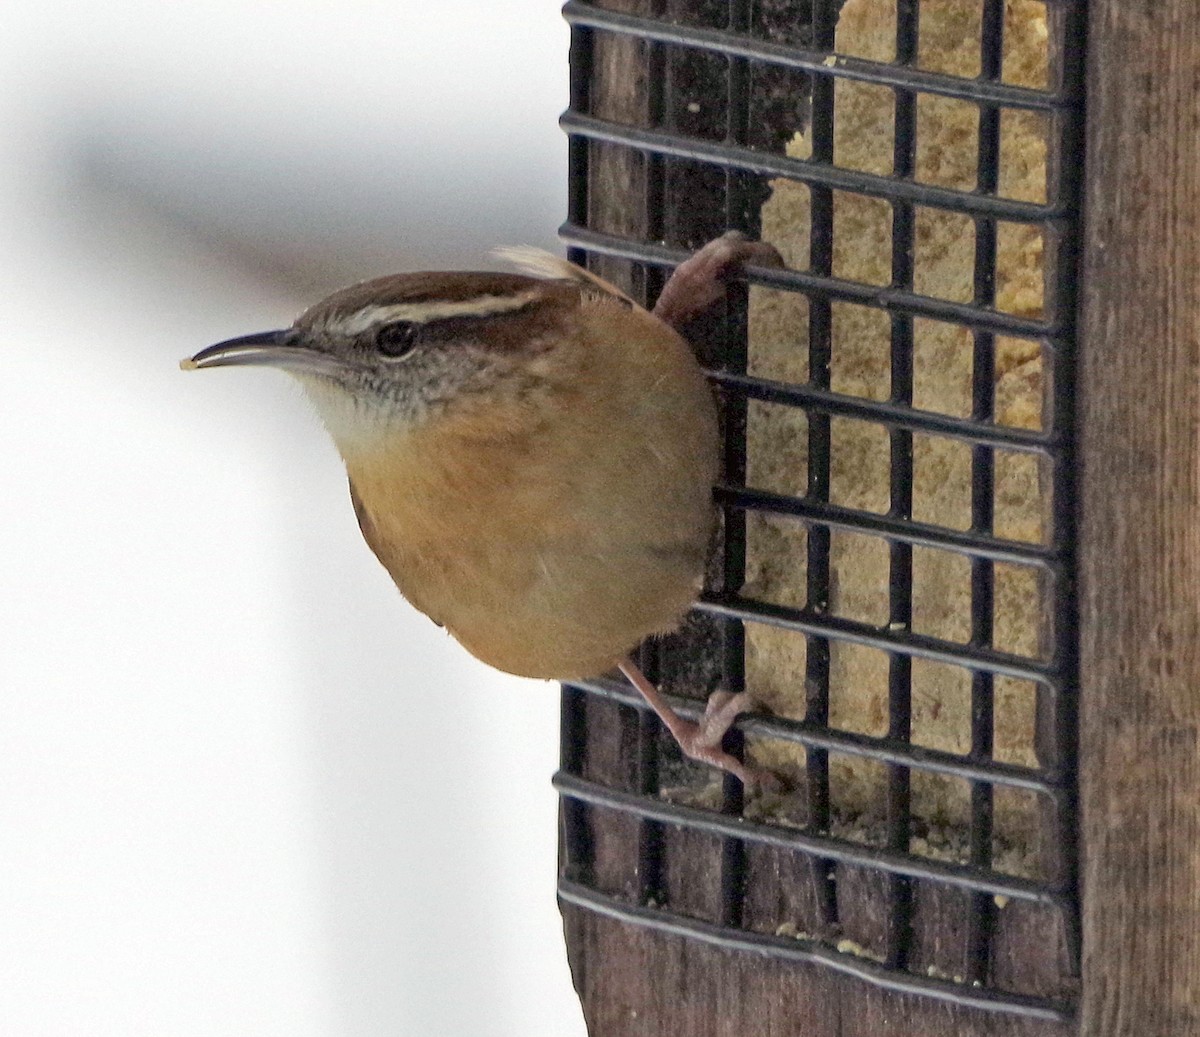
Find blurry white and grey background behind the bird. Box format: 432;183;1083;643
0;0;583;1037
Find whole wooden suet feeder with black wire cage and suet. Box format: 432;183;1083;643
557;0;1200;1037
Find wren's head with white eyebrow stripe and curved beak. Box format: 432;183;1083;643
180;272;580;456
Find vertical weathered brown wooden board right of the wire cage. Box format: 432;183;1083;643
1079;0;1200;1037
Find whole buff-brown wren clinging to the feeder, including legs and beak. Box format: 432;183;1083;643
181;233;780;784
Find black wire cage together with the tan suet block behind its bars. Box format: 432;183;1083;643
556;0;1085;1033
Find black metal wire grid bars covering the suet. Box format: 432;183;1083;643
556;0;1085;1020
